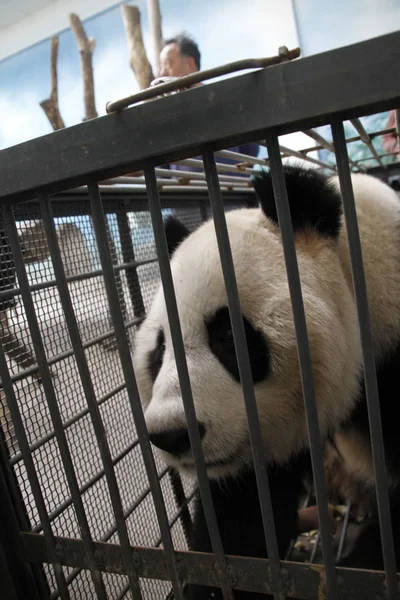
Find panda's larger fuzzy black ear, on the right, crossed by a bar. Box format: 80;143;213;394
252;165;342;237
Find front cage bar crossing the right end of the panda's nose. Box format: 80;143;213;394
145;167;232;600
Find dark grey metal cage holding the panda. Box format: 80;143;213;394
0;33;400;600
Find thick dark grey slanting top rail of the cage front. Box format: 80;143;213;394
0;32;400;202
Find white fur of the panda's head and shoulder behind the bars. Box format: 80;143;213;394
135;175;400;477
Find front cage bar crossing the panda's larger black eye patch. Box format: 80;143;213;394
203;151;284;598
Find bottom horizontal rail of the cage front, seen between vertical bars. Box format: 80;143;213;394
21;533;385;600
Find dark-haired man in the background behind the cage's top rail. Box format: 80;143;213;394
160;34;259;171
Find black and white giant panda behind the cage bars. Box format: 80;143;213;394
134;166;400;600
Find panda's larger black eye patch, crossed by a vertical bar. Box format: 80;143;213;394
205;307;270;383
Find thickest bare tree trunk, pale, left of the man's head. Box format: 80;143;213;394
121;4;154;90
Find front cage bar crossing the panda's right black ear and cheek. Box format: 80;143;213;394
266;135;337;600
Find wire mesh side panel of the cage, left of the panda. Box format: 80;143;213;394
1;185;253;598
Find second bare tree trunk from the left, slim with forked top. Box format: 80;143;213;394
69;13;98;121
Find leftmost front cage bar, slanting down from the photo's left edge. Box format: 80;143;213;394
0;344;70;600
